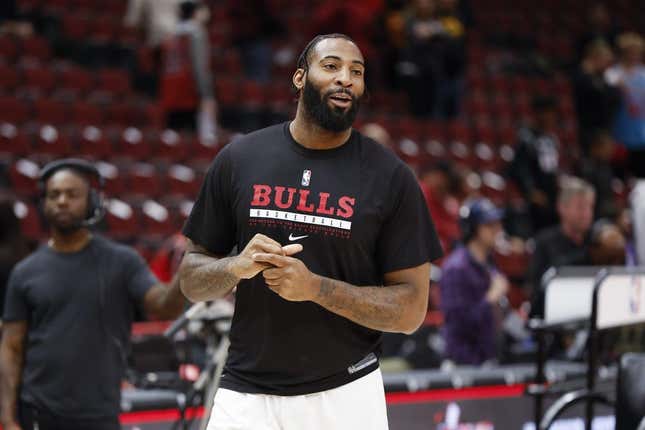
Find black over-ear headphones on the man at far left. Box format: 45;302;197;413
38;158;105;227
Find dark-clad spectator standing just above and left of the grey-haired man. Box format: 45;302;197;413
508;96;560;232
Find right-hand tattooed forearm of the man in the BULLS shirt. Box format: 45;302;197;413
316;276;417;331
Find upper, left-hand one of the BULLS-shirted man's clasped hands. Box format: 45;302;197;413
231;233;302;279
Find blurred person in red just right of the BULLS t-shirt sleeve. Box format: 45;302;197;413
419;161;461;250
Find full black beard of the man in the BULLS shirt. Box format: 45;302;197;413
302;79;361;133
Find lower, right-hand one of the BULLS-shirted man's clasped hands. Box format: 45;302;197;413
253;253;320;302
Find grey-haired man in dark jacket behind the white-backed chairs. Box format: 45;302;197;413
529;177;596;316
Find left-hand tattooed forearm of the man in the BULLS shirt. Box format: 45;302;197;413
180;252;240;301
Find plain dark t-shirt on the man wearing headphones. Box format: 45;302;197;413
4;237;157;419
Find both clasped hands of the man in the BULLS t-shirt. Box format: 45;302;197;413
231;234;320;302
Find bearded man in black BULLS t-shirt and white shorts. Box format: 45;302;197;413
180;34;442;430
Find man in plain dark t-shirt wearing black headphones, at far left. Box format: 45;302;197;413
0;159;184;430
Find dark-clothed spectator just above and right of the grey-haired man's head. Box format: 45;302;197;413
576;130;618;219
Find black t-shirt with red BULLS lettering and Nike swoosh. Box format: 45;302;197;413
184;123;441;395
